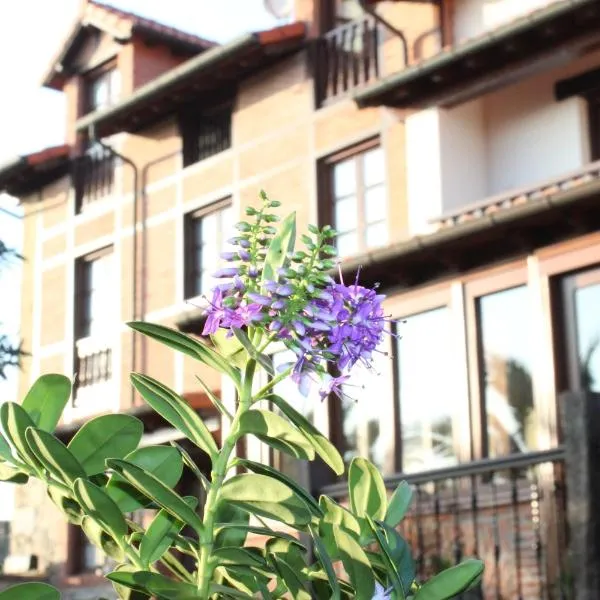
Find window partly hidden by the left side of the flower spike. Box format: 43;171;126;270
184;199;233;298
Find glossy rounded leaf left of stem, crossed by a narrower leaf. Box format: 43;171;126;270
106;446;183;513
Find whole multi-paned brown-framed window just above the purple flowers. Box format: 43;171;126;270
321;141;388;257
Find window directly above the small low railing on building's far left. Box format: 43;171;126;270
75;248;116;339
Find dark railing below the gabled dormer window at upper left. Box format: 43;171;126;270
72;145;117;212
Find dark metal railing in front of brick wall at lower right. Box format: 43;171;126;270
322;448;570;600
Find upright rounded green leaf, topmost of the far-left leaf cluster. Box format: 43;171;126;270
22;374;71;433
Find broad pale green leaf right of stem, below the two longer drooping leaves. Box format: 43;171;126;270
220;473;311;527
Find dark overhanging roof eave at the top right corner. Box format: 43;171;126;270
354;0;600;108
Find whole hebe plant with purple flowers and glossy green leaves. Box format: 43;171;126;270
0;194;483;600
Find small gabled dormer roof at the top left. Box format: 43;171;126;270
42;0;217;90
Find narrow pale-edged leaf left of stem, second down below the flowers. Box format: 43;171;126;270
131;373;219;460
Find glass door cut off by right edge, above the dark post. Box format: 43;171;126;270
559;269;600;393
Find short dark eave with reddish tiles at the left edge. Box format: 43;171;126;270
0;144;71;196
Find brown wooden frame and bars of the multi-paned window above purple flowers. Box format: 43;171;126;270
317;135;390;260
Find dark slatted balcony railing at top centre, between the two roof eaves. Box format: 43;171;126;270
315;17;381;104
